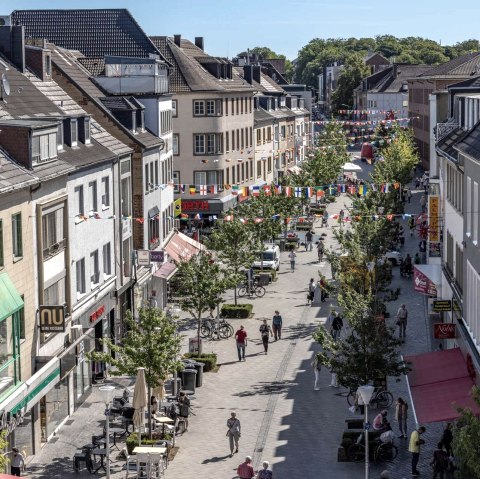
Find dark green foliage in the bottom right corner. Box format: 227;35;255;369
453;387;480;479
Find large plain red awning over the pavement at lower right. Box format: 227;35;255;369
404;348;480;424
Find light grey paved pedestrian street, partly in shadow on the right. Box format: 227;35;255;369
29;165;441;479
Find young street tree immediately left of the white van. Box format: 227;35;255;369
206;214;261;304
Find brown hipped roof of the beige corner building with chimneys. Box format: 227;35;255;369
151;37;254;93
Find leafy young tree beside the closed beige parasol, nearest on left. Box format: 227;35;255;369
87;308;183;437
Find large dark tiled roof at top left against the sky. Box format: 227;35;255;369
12;9;164;58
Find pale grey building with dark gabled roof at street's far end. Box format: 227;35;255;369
354;63;432;121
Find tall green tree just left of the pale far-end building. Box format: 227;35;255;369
332;53;370;110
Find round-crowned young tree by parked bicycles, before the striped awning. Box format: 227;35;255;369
174;251;230;353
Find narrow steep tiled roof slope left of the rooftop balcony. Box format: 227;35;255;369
48;44;161;148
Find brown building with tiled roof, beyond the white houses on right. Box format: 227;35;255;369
408;52;480;169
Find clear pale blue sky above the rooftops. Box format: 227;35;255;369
0;0;480;60
